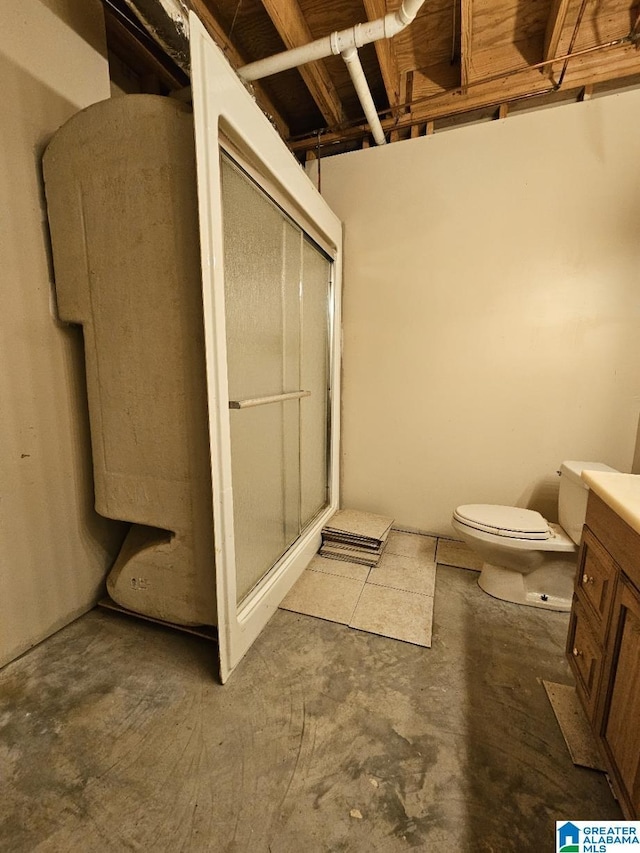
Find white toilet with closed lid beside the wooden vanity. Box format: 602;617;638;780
451;462;615;611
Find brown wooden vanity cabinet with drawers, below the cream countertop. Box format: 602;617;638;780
567;491;640;820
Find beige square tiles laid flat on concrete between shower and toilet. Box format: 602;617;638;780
280;530;481;648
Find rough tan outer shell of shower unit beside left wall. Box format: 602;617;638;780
44;95;216;625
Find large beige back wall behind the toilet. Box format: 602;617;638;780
314;91;640;535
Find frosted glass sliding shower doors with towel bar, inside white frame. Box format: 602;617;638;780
221;155;331;605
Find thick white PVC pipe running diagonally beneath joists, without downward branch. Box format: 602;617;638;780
238;0;424;80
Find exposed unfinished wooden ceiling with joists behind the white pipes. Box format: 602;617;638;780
103;0;640;159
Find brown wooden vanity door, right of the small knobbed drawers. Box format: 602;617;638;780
601;577;640;819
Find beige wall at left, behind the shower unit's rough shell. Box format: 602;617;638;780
0;0;122;664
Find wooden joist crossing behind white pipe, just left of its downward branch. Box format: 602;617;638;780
262;0;344;126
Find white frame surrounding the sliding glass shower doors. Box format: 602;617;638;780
189;12;342;683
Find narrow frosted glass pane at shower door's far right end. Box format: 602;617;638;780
300;239;331;527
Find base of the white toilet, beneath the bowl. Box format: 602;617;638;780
478;560;575;612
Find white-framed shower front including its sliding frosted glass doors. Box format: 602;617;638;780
190;15;342;681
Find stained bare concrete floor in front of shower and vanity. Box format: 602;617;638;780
0;567;621;853
